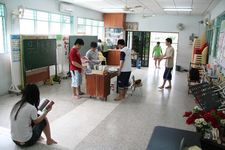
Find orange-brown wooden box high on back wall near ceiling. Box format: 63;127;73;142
103;13;126;29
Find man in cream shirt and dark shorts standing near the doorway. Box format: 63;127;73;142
159;38;174;89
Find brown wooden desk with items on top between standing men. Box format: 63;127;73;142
86;71;118;100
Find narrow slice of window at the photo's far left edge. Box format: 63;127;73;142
0;4;6;53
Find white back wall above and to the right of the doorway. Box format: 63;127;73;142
126;15;204;69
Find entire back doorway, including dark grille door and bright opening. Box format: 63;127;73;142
125;31;178;67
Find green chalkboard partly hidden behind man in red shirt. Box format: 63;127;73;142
69;35;98;56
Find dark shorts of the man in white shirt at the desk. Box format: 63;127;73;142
118;71;131;89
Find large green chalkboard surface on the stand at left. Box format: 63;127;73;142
23;39;57;71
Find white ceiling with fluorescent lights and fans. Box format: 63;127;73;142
59;0;221;15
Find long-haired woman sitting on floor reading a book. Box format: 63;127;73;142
10;84;57;146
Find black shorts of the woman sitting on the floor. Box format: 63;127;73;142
14;119;47;147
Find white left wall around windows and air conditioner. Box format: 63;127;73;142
0;0;103;95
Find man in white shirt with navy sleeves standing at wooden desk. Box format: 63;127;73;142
115;39;131;101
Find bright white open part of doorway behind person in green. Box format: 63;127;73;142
149;32;178;67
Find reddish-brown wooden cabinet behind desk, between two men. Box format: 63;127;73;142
106;50;120;66
